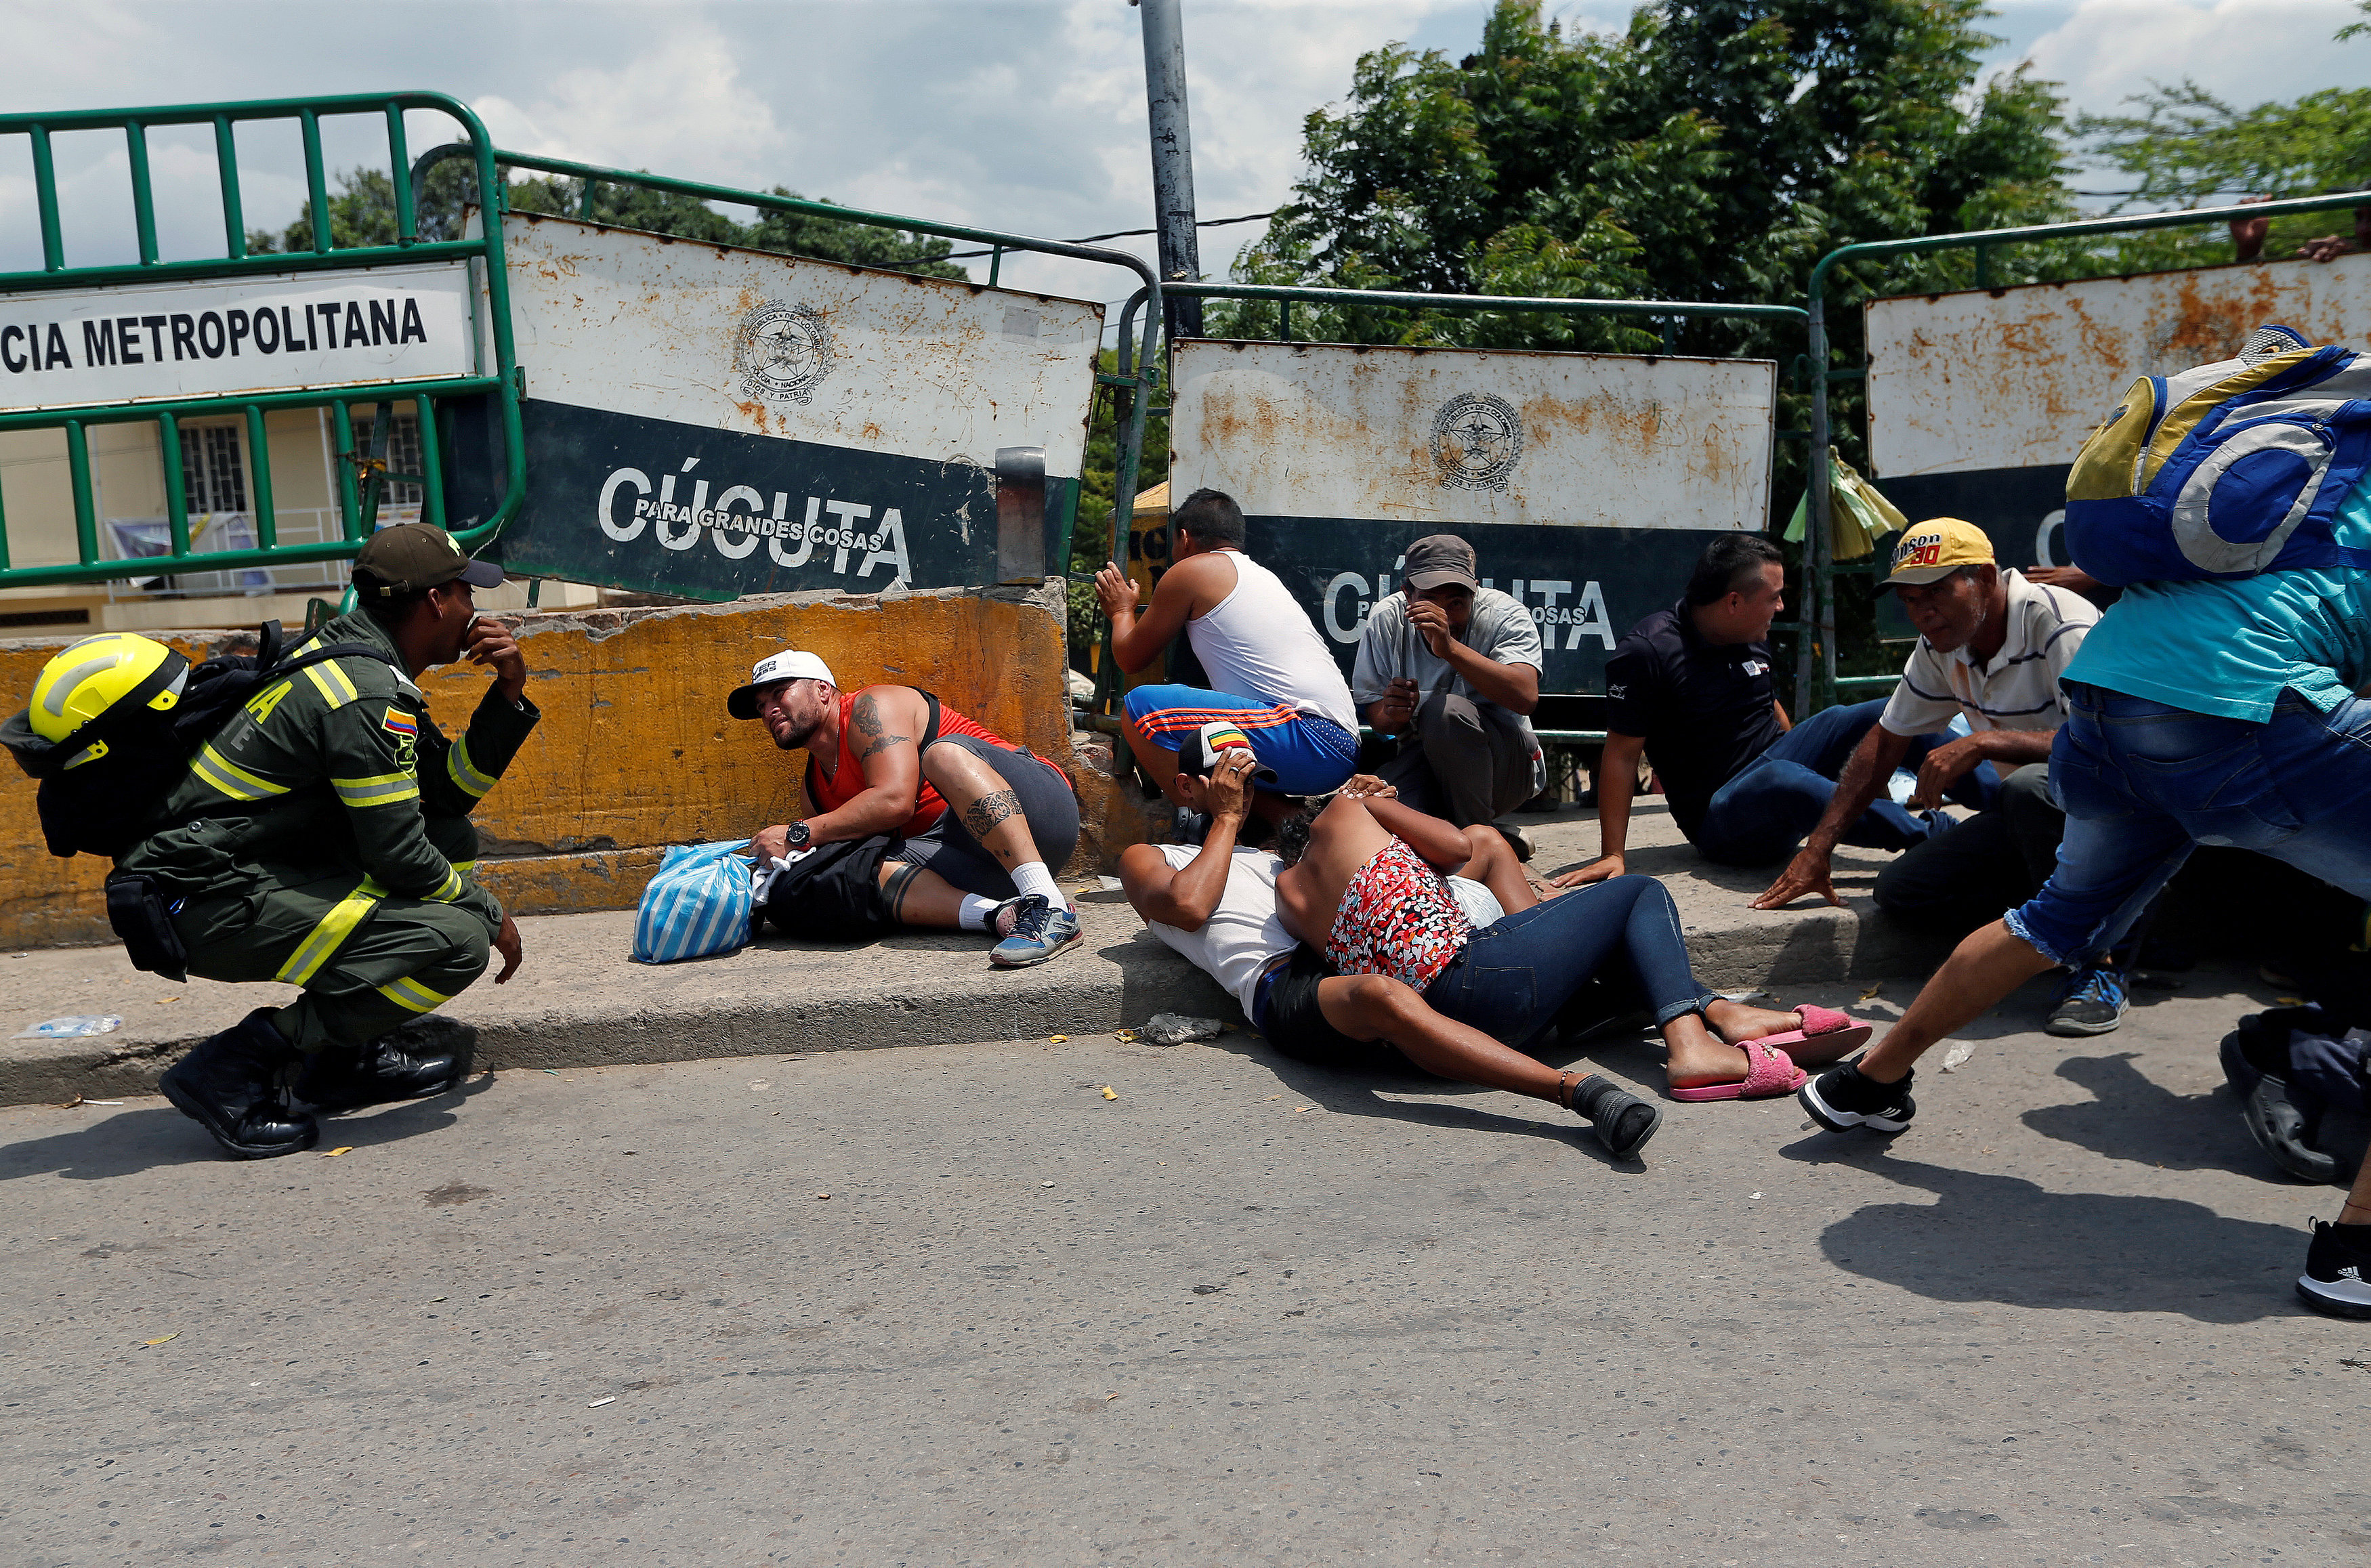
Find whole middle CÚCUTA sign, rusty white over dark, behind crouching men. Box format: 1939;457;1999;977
1169;341;1778;693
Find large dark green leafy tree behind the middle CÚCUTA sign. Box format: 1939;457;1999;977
1217;0;2072;354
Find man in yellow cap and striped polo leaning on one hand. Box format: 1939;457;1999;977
1753;517;2124;1034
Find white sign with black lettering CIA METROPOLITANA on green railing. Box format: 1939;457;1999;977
0;261;477;410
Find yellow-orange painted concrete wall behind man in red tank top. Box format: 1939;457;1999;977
0;584;1141;946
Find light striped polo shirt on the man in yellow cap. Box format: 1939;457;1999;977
1881;567;2099;736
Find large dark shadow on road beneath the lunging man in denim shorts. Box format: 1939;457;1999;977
1781;1134;2307;1323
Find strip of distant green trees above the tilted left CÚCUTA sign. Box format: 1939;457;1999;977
247;159;970;282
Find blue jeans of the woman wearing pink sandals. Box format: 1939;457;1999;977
1425;875;1719;1048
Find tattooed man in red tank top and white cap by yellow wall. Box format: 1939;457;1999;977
726;648;1084;968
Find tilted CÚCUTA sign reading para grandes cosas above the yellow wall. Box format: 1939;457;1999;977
486;213;1103;598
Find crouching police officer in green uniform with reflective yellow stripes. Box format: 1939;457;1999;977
119;522;541;1160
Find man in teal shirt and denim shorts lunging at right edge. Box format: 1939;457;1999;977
1800;467;2371;1319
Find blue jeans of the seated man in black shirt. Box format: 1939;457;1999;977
1688;698;2001;866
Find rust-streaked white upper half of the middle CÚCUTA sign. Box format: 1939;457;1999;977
1169;341;1778;529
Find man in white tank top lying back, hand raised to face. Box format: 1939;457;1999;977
1119;726;1660;1156
